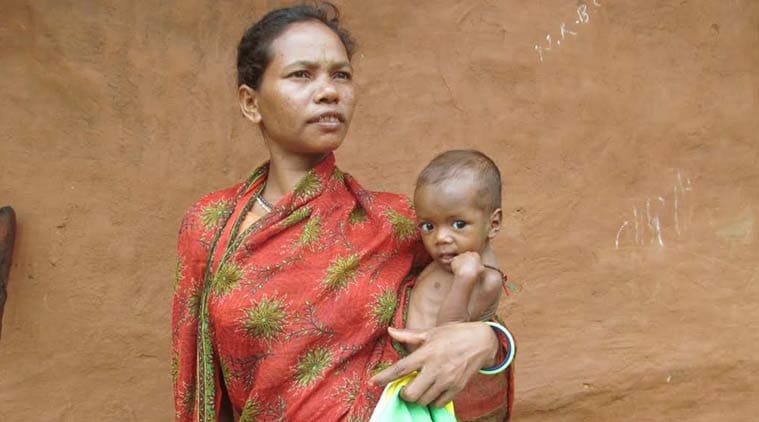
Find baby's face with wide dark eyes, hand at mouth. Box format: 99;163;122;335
414;178;492;271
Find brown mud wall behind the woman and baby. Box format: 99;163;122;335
0;0;759;421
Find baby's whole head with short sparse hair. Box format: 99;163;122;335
414;150;502;269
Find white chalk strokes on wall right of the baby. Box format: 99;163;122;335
614;170;693;249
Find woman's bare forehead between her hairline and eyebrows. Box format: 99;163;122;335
271;21;348;66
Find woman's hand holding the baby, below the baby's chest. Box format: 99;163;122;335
371;322;498;407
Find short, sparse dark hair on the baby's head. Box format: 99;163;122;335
416;149;501;212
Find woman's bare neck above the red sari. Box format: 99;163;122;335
262;151;326;203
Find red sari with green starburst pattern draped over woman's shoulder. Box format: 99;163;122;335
172;154;505;421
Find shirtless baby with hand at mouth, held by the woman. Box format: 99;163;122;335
406;150;504;329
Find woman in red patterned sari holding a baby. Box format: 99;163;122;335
172;4;508;421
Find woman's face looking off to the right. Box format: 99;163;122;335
249;22;355;155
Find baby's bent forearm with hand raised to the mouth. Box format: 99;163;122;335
437;252;484;325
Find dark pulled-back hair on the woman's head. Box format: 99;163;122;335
237;1;356;89
